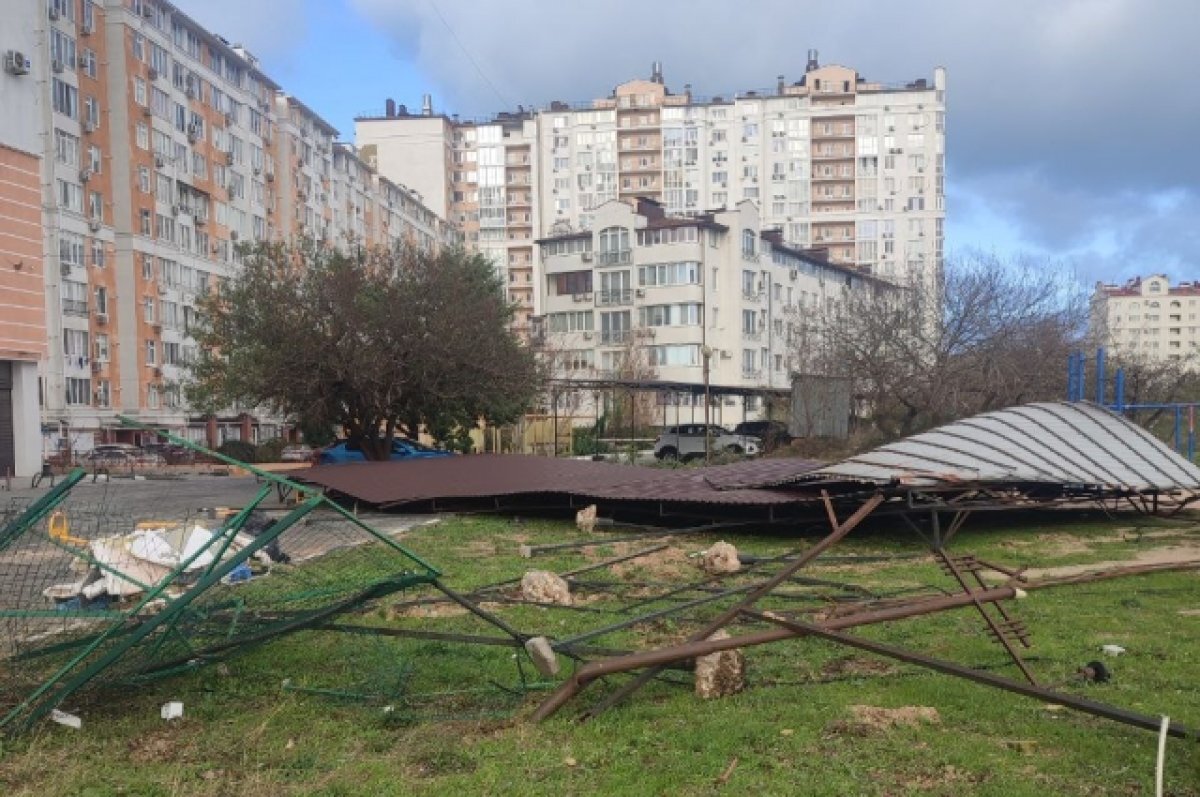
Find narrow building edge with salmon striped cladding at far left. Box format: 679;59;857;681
0;0;46;479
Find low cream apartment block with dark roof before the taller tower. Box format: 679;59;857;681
533;198;887;412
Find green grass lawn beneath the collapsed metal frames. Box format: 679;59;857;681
0;514;1200;797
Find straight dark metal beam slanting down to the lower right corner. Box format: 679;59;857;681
753;617;1195;738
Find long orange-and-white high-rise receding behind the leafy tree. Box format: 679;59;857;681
11;0;455;458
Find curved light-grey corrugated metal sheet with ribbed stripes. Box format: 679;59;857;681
791;402;1200;491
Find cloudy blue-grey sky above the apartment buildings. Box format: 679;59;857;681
175;0;1200;284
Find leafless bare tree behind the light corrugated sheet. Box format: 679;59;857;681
792;254;1087;439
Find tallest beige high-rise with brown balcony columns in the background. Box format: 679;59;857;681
355;52;946;331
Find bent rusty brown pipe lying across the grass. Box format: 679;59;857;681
533;578;1018;721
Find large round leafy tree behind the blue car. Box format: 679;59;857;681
188;240;540;460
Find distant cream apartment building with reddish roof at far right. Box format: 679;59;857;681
1091;274;1200;366
